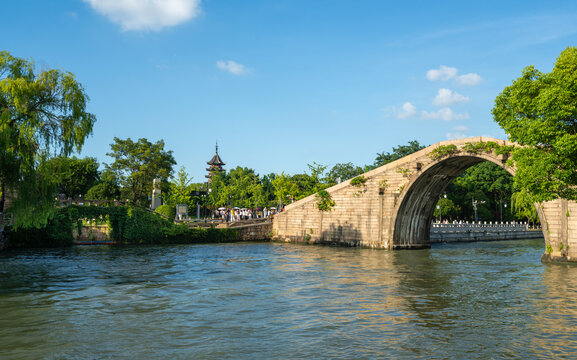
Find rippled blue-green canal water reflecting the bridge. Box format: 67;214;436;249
0;240;577;359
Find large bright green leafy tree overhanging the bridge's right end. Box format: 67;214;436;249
492;47;577;202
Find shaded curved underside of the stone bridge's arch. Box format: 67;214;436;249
392;155;520;249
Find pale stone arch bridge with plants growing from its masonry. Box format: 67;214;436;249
273;137;577;261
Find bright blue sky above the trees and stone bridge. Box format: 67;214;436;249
0;0;577;182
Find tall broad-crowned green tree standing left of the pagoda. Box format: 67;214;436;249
106;137;176;206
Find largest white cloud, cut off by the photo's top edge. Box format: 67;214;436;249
84;0;201;31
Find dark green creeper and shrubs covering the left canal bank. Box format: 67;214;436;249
6;206;238;247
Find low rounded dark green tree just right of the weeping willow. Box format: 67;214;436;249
48;156;98;198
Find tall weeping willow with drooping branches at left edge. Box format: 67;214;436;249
0;51;96;227
